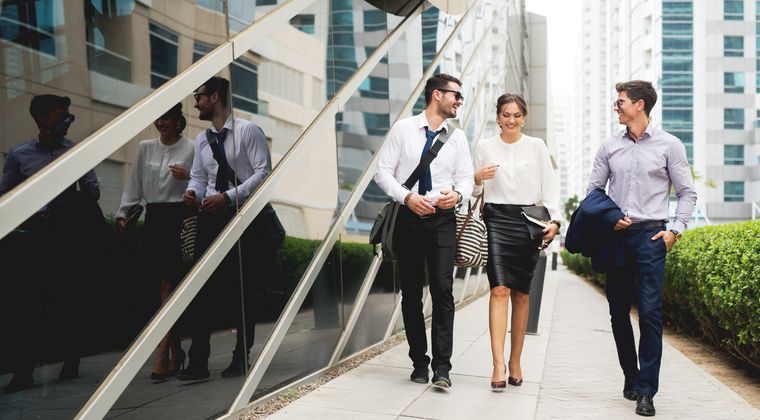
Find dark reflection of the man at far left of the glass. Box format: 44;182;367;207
0;95;103;393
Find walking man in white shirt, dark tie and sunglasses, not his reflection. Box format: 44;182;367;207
375;74;473;388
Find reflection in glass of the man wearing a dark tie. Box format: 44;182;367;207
178;77;285;380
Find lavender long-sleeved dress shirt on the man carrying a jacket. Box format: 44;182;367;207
586;124;697;232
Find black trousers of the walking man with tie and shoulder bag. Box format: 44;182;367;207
394;206;456;372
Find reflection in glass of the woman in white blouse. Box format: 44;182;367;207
116;103;194;380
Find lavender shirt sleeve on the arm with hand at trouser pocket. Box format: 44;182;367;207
667;142;697;232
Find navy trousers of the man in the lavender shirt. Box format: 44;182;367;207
606;228;666;396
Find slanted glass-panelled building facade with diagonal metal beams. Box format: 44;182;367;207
0;0;547;419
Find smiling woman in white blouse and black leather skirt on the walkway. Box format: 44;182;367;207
473;94;559;392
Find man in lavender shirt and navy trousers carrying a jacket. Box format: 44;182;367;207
586;80;697;416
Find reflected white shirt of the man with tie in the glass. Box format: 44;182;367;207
188;115;272;203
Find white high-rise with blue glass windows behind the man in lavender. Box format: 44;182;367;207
581;0;760;223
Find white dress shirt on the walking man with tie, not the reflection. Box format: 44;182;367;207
375;113;473;205
